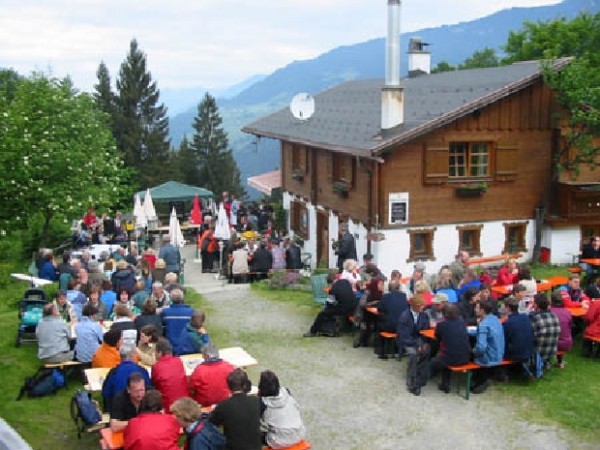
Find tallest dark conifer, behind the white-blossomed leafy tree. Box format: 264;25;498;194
115;39;170;188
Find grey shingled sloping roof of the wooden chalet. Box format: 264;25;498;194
242;58;569;158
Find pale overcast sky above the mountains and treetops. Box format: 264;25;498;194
0;0;560;90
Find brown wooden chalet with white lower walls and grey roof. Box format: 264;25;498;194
243;2;600;273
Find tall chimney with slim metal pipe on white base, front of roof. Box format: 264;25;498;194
381;0;404;130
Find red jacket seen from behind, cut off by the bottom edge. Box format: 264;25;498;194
123;413;181;450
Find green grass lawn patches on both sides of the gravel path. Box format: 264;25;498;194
0;266;600;450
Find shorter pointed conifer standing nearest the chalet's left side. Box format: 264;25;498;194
191;92;246;198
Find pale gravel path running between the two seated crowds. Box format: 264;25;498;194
184;248;593;450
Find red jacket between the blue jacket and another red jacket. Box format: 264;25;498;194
152;355;190;412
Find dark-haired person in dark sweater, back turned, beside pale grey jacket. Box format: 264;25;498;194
209;369;262;450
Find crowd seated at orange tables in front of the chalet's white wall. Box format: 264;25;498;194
304;230;600;395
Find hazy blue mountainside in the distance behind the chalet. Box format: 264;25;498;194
161;0;600;197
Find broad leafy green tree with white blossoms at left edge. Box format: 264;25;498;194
0;75;131;246
